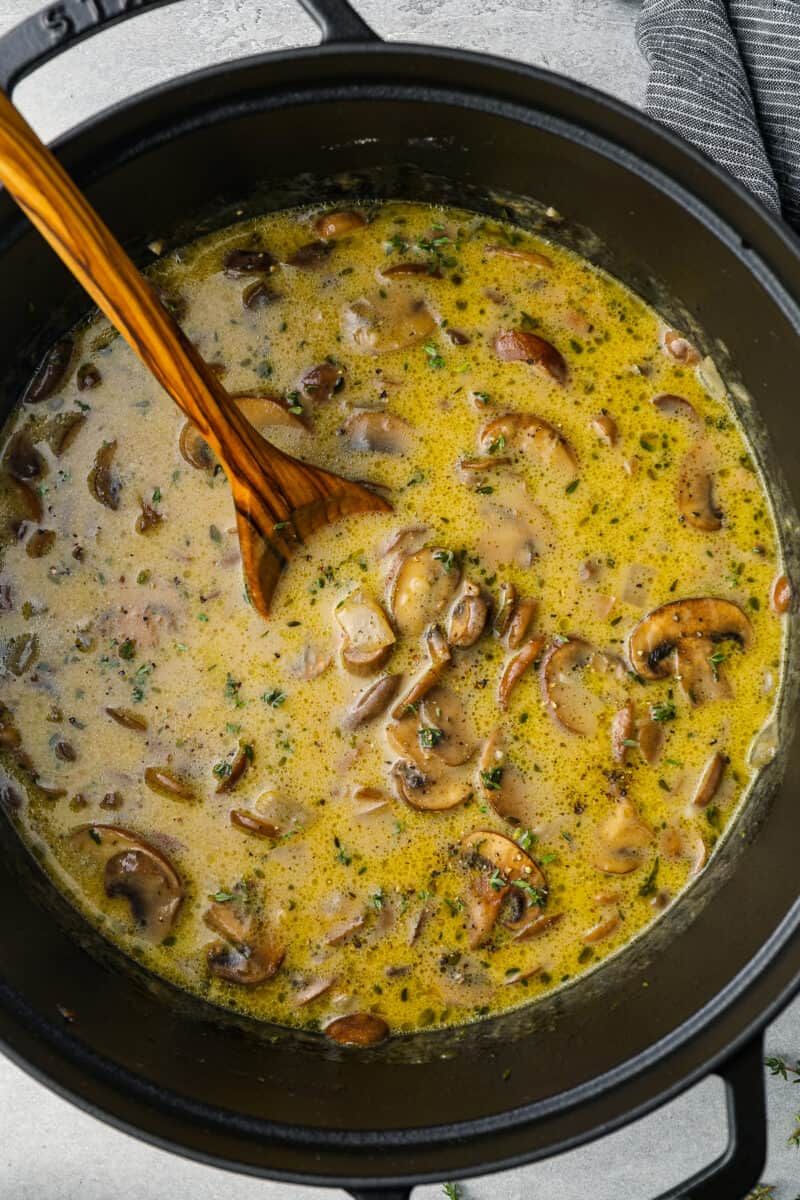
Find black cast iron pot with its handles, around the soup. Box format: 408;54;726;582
0;0;800;1200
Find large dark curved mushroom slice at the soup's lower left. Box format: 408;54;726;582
70;824;184;941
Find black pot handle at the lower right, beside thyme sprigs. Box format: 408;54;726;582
658;1033;766;1200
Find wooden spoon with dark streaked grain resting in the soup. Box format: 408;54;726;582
0;92;391;617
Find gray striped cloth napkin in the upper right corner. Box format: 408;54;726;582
637;0;800;232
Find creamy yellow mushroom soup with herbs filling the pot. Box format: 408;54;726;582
0;203;789;1043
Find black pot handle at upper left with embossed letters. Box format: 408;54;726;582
0;0;380;96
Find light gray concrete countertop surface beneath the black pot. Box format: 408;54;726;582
0;0;800;1200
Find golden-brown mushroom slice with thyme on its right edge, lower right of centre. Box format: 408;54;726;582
459;829;547;949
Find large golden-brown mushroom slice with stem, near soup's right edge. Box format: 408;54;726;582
627;596;753;704
